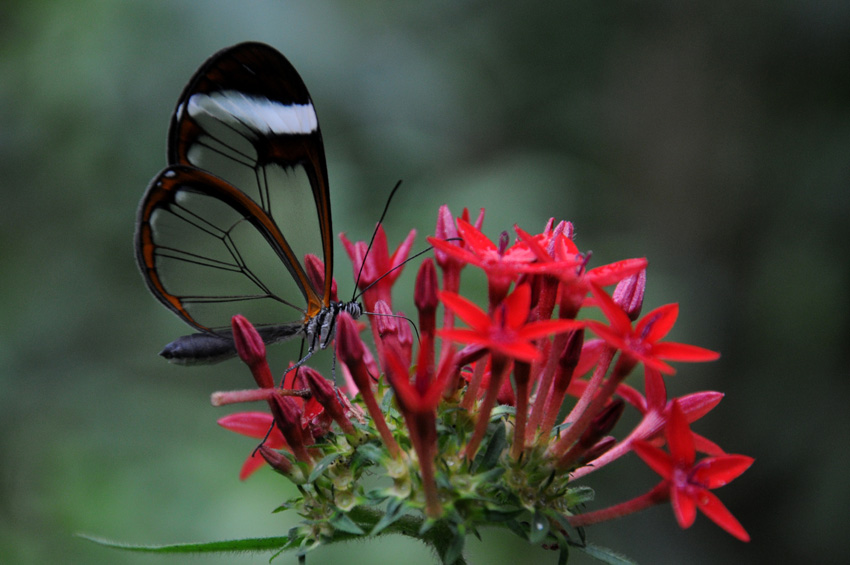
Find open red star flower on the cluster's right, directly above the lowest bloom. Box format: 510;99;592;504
585;284;720;375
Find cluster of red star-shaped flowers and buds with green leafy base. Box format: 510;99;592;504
214;207;753;563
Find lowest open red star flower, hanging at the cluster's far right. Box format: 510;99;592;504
633;401;754;541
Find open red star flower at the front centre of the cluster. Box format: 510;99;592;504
437;284;582;363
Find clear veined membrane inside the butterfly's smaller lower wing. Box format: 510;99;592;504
144;172;314;329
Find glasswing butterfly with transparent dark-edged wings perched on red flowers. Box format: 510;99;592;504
135;42;363;364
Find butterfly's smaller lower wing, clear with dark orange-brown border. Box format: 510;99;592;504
140;166;318;330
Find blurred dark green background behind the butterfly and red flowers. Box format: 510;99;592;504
0;0;850;565
